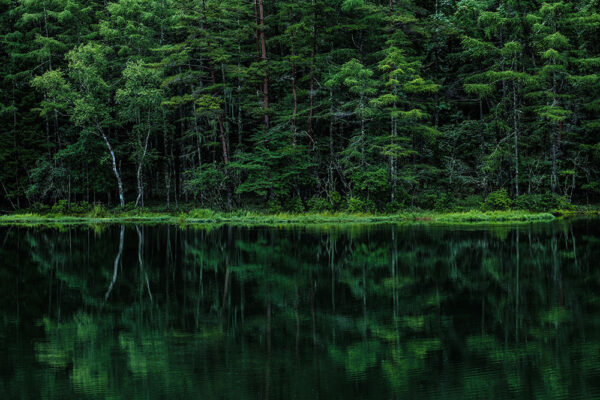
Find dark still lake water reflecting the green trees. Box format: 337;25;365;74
0;220;600;400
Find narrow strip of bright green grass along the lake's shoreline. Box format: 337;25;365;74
0;210;576;225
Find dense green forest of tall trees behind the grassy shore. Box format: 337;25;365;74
0;0;600;211
